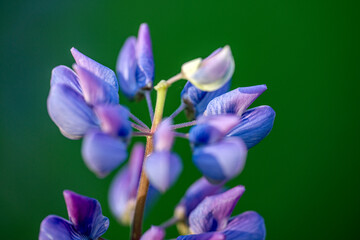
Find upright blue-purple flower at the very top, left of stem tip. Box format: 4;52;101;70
116;23;154;99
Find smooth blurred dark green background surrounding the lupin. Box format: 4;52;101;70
0;0;360;240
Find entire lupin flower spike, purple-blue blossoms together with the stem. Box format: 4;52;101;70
39;24;275;240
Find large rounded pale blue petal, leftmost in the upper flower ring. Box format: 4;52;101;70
47;84;98;139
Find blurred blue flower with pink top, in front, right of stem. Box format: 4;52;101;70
189;115;247;183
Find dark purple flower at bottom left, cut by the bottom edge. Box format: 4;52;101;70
39;190;109;240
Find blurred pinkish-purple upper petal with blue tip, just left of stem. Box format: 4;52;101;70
94;104;131;140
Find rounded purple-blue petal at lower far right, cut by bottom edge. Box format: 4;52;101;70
222;211;266;240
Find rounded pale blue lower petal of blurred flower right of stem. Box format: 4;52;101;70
193;138;247;183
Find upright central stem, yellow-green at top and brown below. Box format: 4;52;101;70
131;80;169;240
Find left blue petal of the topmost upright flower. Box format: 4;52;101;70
116;37;139;99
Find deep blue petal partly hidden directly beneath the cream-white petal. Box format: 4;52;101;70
181;80;231;119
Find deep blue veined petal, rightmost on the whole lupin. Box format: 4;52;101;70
228;106;275;149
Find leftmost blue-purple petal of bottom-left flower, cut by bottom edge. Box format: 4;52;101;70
39;215;78;240
